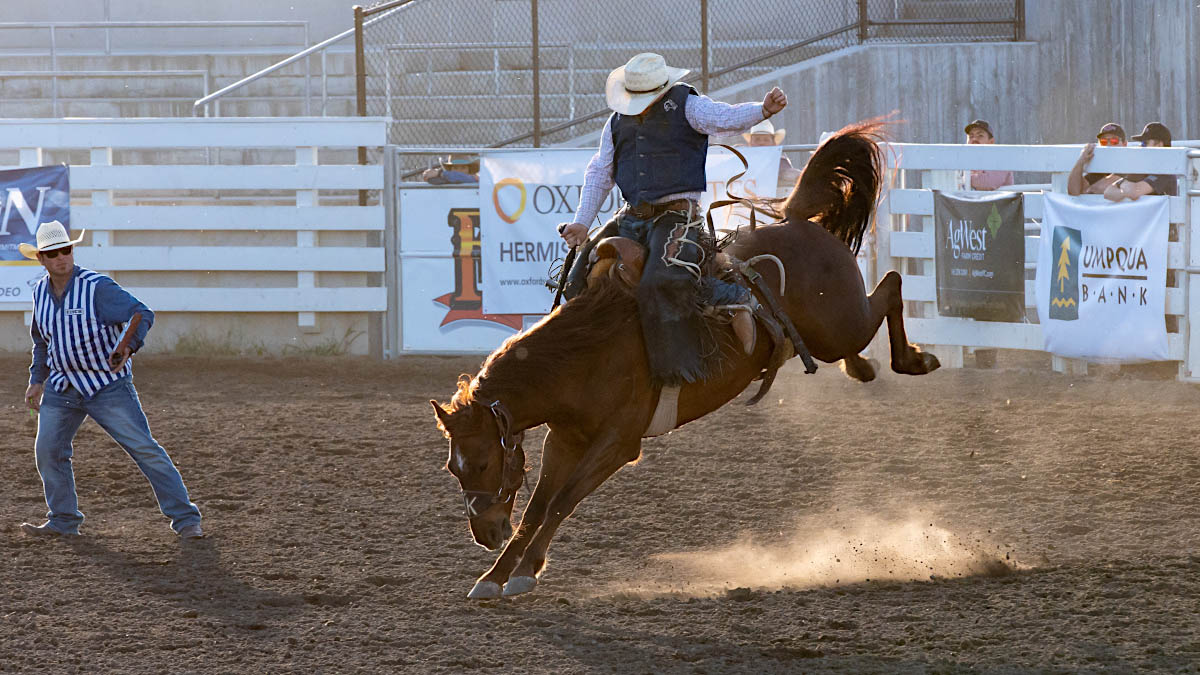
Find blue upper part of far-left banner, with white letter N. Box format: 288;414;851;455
0;165;71;264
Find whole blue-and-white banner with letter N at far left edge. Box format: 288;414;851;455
0;165;71;303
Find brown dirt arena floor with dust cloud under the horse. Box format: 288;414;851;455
0;352;1200;673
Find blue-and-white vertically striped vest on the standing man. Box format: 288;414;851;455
34;268;133;399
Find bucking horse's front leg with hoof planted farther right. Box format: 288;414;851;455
504;429;642;597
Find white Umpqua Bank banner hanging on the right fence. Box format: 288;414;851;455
1037;192;1169;362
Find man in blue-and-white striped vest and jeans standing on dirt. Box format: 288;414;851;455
19;220;204;539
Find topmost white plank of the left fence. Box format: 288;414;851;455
0;117;388;149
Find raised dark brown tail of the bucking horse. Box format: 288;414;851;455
784;119;887;255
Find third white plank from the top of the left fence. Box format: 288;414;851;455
71;207;383;231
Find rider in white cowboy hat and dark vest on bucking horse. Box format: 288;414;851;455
558;53;787;387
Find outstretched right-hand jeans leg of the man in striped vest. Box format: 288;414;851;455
84;377;200;532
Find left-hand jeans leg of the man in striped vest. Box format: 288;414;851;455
34;384;85;534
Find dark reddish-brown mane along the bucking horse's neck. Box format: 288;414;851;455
449;279;641;412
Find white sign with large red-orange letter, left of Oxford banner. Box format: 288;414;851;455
400;187;530;353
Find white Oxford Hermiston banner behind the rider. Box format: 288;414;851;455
479;145;781;315
